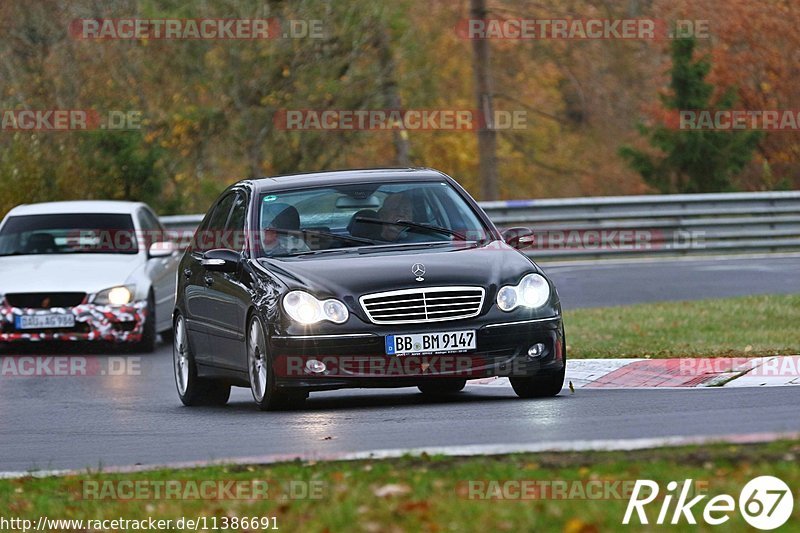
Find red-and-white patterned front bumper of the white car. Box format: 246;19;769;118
0;300;148;343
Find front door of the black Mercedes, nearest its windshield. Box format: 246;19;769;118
204;190;250;369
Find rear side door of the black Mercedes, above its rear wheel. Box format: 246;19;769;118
178;195;234;364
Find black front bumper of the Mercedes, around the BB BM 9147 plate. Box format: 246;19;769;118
270;316;566;390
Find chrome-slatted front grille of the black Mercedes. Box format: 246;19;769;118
361;287;485;324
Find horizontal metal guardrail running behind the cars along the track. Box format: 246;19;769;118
161;191;800;260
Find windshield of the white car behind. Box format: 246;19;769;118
0;213;139;256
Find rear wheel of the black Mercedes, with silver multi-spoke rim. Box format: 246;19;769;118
172;314;231;406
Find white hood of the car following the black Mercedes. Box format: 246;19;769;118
0;254;141;294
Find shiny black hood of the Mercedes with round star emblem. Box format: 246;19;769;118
260;241;540;299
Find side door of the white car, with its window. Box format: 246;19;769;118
137;207;179;331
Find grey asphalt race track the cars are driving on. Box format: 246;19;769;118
0;258;800;471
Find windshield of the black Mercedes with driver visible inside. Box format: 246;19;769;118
258;181;488;257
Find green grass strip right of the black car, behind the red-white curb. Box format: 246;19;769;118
564;295;800;358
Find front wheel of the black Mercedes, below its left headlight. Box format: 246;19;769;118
247;315;300;411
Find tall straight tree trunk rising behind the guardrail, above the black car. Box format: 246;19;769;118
470;0;498;200
